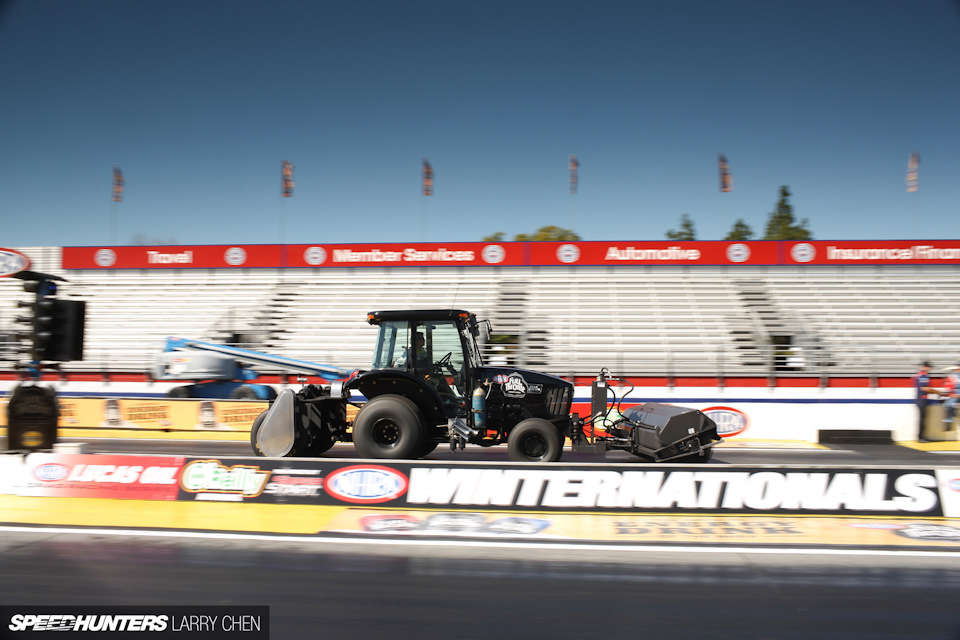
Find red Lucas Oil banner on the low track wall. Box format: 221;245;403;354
18;453;184;500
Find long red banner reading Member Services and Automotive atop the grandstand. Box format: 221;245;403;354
63;240;960;269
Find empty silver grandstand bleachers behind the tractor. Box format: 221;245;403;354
0;247;960;377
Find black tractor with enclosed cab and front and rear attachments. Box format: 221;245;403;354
250;309;719;462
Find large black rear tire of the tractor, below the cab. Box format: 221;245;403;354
353;395;426;460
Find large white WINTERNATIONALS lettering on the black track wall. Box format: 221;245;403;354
407;467;942;515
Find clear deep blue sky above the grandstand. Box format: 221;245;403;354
0;0;960;247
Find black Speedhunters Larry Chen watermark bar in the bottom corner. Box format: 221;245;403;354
0;606;270;640
